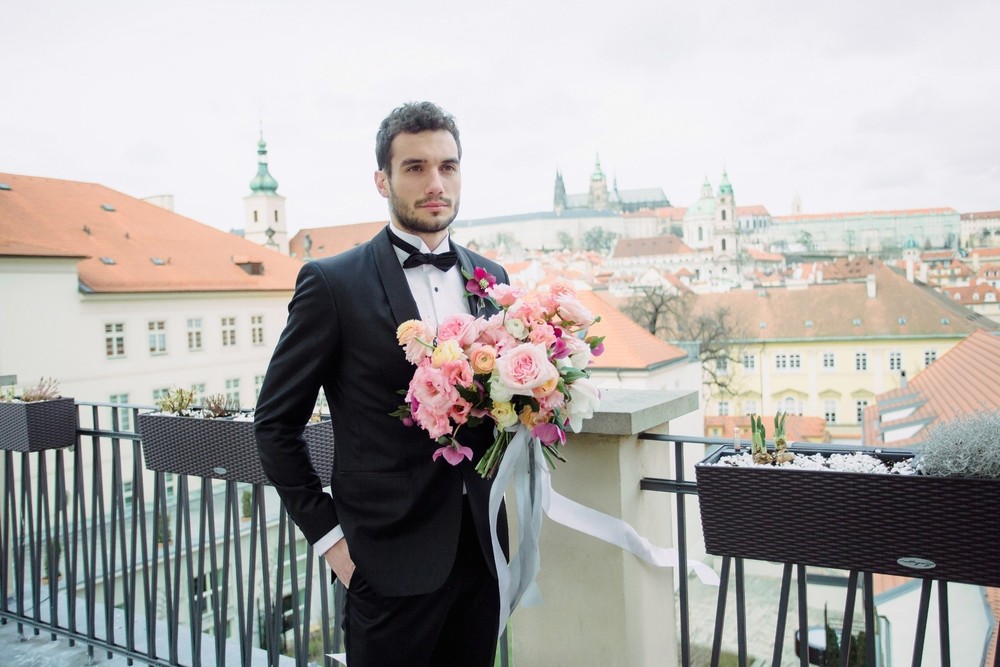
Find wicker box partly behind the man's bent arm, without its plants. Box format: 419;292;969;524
138;414;333;484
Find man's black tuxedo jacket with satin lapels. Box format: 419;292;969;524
254;229;508;596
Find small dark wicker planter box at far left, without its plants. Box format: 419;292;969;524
0;398;76;452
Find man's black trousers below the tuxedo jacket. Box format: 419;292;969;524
344;499;500;667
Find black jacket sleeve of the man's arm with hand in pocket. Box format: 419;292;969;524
254;263;340;544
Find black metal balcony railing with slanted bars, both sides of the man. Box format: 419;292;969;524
0;403;1000;666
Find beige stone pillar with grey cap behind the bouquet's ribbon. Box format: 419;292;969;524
508;390;698;667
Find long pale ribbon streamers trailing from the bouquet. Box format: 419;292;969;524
490;425;719;636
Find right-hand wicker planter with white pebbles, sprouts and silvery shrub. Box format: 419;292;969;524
695;412;1000;587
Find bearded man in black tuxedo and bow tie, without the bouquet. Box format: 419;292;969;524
254;102;508;667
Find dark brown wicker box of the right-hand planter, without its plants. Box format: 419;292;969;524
695;445;1000;587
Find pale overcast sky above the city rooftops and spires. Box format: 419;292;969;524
0;0;1000;233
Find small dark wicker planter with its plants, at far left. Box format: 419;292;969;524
0;378;76;452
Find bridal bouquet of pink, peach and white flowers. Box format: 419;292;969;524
392;268;604;477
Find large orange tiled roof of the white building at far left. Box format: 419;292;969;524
0;174;301;292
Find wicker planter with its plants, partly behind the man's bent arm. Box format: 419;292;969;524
137;389;333;484
